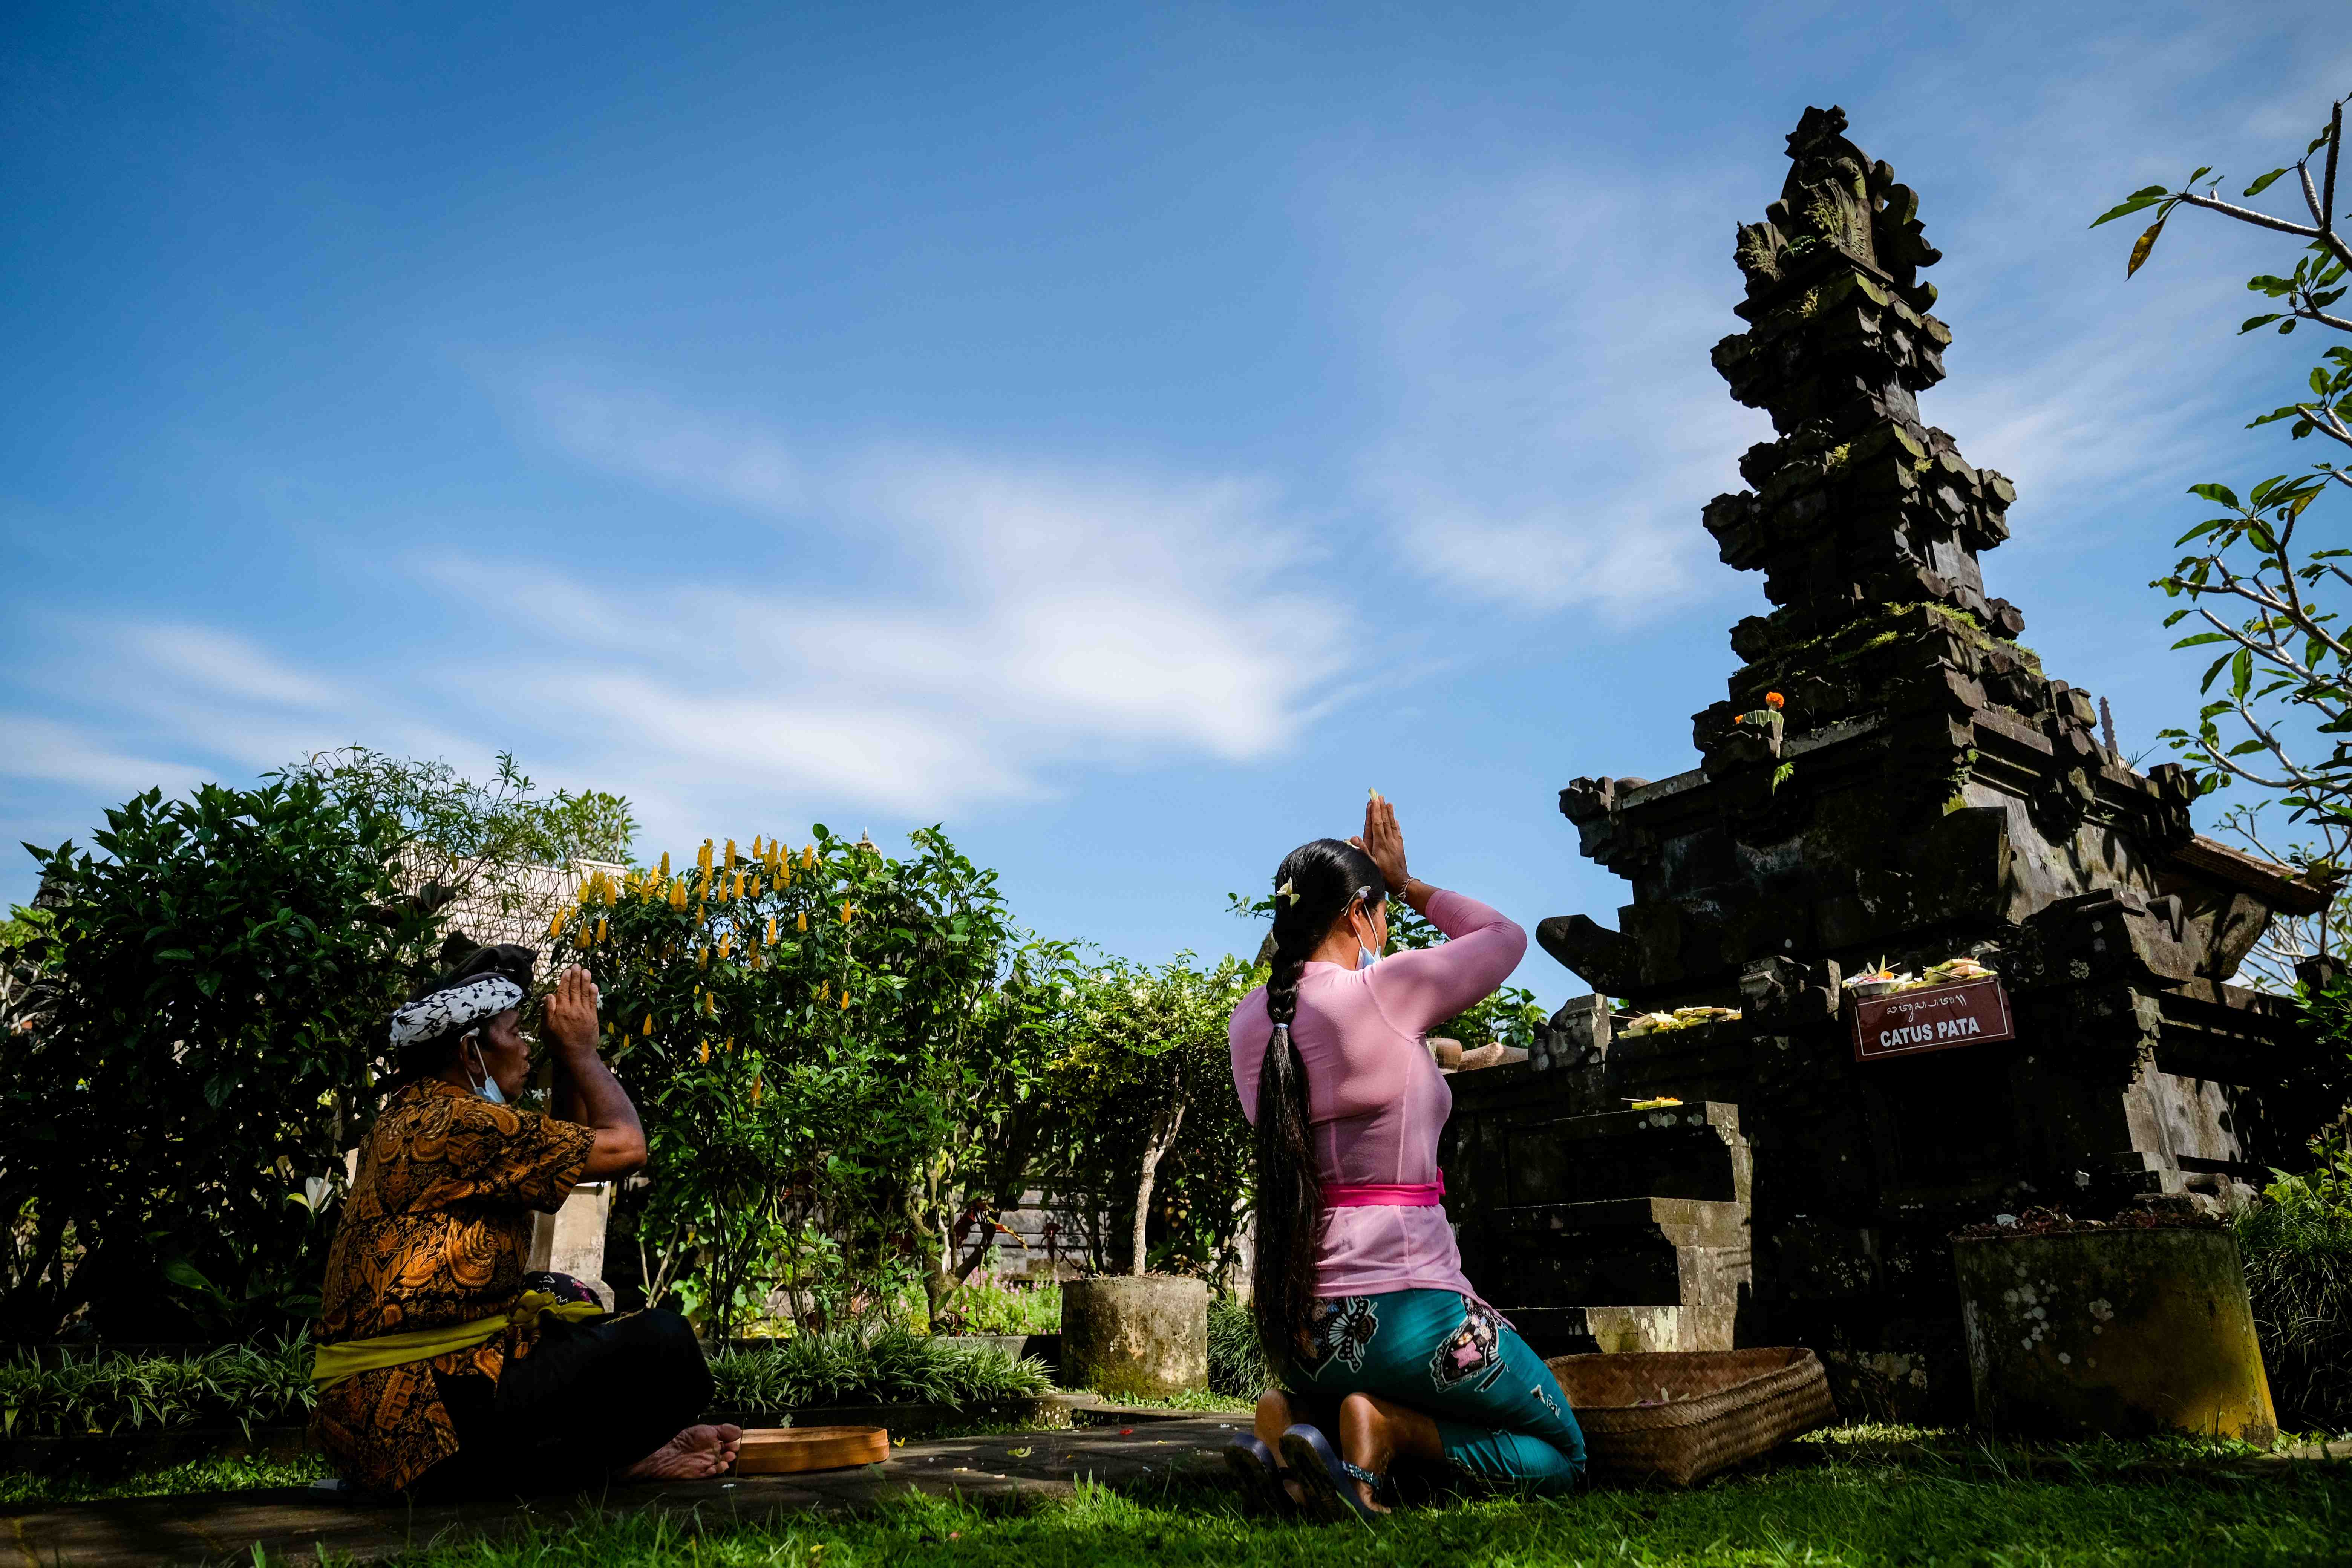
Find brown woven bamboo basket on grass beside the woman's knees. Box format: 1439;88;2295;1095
1545;1347;1837;1486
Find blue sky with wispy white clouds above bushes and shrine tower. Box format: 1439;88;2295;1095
0;0;2352;1001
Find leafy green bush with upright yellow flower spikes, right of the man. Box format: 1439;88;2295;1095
574;825;1068;1335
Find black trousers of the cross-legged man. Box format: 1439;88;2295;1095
414;1309;710;1498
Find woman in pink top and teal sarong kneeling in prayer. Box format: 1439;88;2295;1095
1228;797;1585;1514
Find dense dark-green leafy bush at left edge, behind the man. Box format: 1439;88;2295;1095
0;778;433;1340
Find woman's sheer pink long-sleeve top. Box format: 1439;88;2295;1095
1225;891;1527;1298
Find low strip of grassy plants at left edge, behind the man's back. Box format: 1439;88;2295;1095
0;1338;313;1436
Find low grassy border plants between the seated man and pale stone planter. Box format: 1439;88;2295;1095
710;1328;1054;1413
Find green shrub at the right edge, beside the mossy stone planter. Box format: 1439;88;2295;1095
2237;1145;2352;1432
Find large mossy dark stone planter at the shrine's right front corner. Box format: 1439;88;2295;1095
1952;1227;2279;1448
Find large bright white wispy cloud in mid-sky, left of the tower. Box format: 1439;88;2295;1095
419;381;1350;816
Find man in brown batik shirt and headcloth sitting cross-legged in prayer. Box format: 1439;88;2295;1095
313;947;743;1495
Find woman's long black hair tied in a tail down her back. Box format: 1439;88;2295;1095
1249;839;1388;1368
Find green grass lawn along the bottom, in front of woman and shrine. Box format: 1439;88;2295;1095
352;1427;2352;1568
